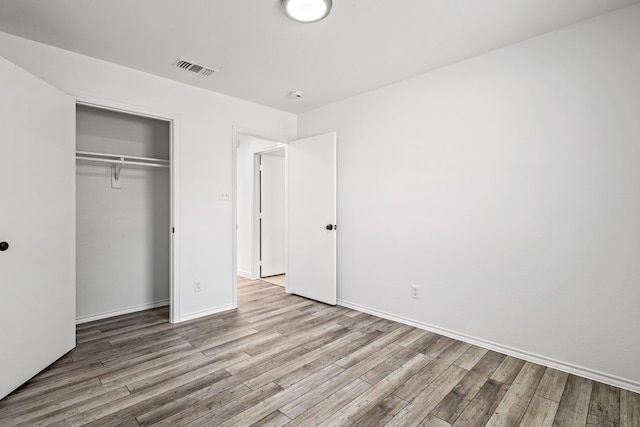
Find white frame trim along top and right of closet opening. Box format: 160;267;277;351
69;93;181;323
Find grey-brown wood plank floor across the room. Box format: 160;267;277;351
0;279;640;427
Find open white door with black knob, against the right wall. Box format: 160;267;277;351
286;133;337;305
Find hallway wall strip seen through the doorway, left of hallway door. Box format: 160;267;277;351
236;134;278;279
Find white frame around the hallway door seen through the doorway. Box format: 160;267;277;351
251;147;289;279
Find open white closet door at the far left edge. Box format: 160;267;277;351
0;58;75;398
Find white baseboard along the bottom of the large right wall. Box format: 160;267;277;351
338;300;640;393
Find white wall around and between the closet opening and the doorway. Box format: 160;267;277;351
0;33;296;319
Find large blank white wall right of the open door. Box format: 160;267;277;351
298;5;640;391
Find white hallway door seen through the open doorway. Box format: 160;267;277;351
260;154;286;277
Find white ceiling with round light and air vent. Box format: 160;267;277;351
0;0;640;113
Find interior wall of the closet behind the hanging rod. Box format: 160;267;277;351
76;105;170;323
